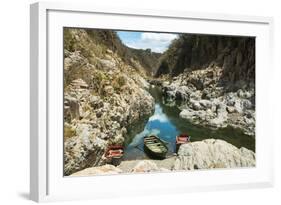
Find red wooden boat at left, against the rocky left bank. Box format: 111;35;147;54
105;145;124;166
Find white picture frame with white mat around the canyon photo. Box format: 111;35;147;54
30;2;273;202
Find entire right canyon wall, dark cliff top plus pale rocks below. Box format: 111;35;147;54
156;34;255;136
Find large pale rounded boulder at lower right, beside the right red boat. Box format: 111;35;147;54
174;139;256;170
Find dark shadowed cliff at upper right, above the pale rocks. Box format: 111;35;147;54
156;34;255;85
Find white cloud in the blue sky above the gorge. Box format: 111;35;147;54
122;32;178;53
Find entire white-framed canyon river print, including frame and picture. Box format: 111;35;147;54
30;3;273;201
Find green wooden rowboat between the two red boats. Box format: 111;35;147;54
143;135;168;159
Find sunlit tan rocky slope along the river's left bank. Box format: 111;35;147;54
64;29;154;175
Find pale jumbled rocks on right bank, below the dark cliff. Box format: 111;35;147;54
158;65;255;137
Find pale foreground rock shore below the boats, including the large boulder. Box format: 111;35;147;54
71;139;255;176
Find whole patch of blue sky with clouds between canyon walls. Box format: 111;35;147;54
117;31;178;53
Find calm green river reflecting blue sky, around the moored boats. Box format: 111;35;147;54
123;87;255;160
